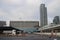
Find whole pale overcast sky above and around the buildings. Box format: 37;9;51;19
0;0;60;23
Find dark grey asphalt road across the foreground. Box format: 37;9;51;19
0;34;60;40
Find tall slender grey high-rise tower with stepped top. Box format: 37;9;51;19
40;4;48;26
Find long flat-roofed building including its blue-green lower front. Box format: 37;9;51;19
10;21;39;32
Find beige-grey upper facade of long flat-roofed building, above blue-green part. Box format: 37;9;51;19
10;21;39;28
